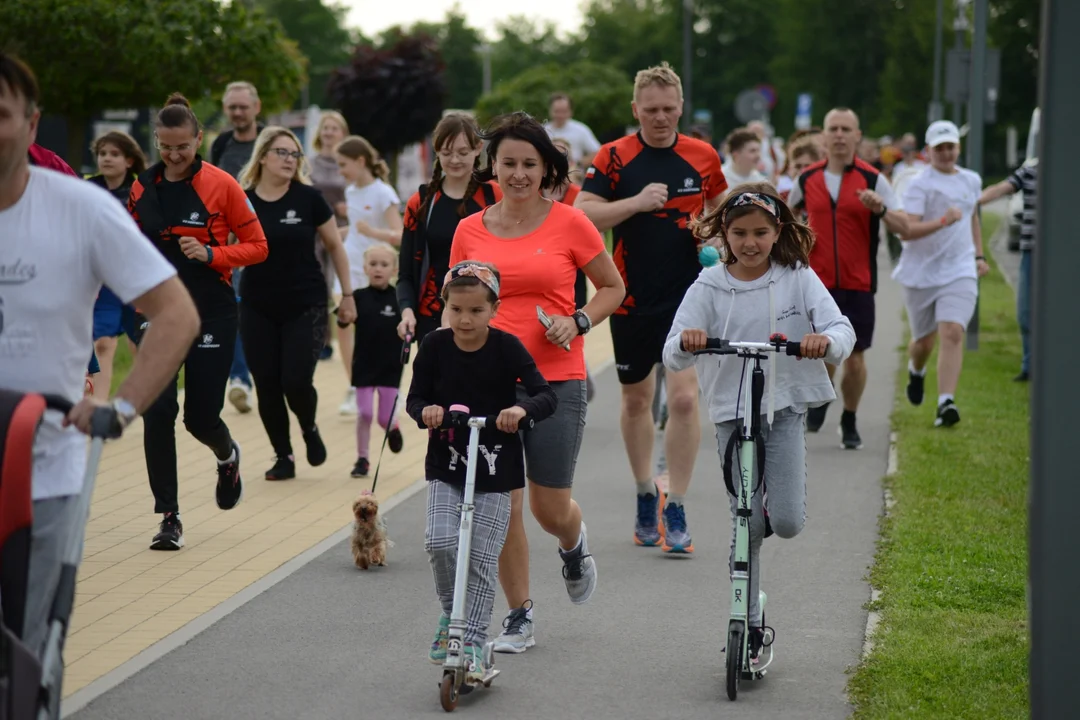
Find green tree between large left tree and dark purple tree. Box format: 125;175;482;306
258;0;353;106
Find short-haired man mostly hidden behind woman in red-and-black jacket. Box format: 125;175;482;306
210;81;262;412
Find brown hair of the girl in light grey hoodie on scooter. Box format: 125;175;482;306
690;182;814;270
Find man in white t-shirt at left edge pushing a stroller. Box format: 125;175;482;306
0;53;199;705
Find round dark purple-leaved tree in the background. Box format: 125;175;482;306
328;32;446;157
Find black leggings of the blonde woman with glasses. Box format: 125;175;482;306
240;302;327;457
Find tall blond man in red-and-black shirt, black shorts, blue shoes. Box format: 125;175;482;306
577;63;728;553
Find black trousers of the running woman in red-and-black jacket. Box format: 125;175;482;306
143;313;237;513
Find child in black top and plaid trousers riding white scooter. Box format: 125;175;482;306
406;261;557;681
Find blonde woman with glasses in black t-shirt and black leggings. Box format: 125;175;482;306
240;126;355;480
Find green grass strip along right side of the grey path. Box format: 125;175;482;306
849;213;1029;720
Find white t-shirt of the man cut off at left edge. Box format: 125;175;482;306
0;167;176;500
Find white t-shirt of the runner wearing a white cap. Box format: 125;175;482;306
892;167;983;287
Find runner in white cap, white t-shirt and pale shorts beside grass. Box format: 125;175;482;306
892;120;990;427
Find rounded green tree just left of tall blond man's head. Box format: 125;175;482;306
476;60;634;137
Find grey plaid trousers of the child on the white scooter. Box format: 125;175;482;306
423;480;510;644
